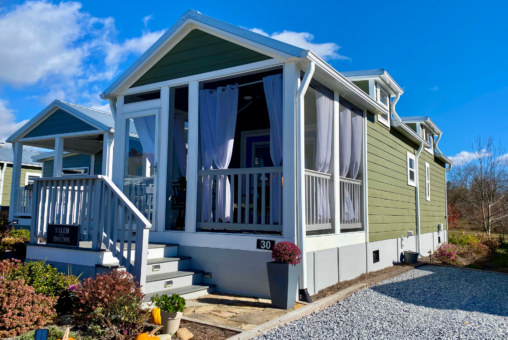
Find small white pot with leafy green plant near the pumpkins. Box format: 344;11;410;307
151;294;185;334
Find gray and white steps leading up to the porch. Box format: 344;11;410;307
96;243;215;300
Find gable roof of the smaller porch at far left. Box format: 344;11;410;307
7;100;115;142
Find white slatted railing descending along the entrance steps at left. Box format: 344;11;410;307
31;175;152;285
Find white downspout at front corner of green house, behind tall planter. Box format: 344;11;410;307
296;61;316;302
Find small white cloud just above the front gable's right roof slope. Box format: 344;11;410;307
250;28;351;60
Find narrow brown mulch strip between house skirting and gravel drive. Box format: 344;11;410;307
311;264;415;301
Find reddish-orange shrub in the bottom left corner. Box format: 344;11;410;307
0;279;55;338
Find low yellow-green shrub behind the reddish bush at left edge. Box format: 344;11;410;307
0;260;68;297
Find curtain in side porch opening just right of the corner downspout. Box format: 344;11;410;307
315;89;333;220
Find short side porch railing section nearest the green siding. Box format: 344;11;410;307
340;177;362;230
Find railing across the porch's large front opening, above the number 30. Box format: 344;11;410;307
197;167;283;233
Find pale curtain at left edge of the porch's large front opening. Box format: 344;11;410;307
199;85;238;222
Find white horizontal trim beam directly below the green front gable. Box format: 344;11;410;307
122;59;283;96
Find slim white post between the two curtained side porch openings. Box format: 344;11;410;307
332;92;341;234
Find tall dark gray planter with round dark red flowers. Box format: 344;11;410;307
267;241;302;309
